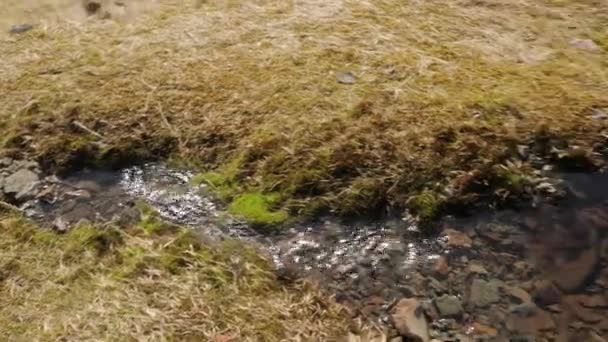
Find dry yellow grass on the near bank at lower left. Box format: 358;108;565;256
0;207;348;342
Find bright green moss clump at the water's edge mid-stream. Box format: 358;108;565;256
229;192;289;225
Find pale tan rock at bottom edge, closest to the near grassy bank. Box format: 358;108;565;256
392;298;429;342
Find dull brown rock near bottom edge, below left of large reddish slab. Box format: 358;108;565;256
507;303;555;335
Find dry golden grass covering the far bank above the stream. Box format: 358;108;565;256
0;0;608;218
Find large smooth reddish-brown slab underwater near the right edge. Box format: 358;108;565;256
550;248;600;292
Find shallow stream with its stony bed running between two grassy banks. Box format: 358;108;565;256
1;159;608;341
